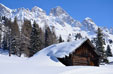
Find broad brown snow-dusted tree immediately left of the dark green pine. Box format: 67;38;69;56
20;20;32;57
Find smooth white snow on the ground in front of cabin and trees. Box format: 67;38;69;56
0;52;113;74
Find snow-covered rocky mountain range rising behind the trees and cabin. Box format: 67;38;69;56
0;4;113;48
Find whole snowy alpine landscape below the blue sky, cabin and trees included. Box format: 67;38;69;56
0;4;113;74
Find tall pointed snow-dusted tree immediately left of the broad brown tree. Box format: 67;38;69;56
10;17;20;56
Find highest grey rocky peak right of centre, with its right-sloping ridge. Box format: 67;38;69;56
50;6;81;27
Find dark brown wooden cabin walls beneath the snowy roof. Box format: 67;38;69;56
58;39;99;66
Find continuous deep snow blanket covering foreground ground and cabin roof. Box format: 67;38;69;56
0;39;113;74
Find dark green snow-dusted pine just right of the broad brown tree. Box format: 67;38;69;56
30;22;42;56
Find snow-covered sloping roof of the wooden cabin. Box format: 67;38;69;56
39;38;87;58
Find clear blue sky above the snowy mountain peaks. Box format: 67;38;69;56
0;0;113;28
